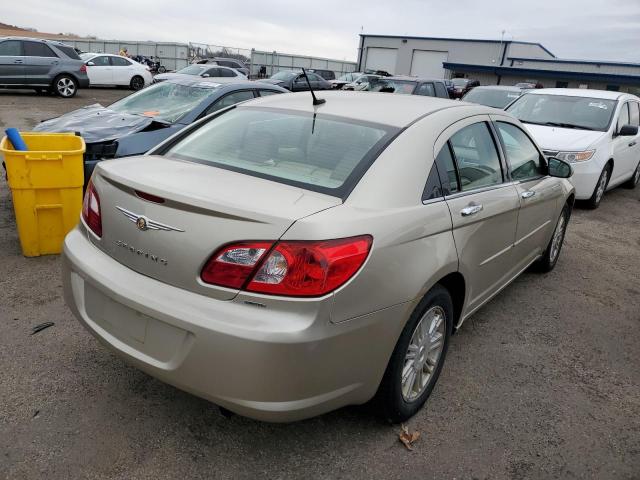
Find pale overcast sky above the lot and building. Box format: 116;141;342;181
5;0;640;62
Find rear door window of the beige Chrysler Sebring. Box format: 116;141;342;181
450;122;502;192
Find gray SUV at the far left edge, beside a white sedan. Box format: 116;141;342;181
0;37;89;98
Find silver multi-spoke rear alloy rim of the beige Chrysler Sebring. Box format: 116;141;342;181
402;305;446;402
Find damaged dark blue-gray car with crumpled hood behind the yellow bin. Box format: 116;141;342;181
34;77;286;184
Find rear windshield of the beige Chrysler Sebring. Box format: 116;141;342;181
166;107;397;198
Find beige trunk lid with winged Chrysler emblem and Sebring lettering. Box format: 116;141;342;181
92;155;341;300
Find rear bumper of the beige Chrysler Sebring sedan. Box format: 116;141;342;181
63;227;412;421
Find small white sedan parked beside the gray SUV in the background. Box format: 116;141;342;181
80;53;153;90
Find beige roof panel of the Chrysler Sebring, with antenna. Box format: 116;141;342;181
240;90;471;128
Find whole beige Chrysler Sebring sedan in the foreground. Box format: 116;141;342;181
63;92;574;421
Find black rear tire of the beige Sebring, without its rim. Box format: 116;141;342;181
374;285;453;423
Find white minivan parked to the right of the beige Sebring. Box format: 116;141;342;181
507;88;640;208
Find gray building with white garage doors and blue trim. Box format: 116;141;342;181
358;34;640;94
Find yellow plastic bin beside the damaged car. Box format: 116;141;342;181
0;132;86;257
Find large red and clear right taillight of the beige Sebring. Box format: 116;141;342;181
201;235;372;297
